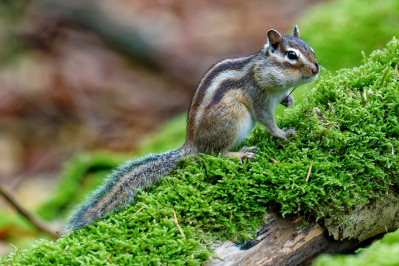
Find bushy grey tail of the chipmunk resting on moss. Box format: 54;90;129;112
63;146;193;232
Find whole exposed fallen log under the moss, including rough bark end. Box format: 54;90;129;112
208;196;399;265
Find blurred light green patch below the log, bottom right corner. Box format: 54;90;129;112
313;230;399;266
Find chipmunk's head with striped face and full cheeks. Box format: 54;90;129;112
255;26;320;87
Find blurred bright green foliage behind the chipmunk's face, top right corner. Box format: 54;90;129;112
298;0;399;70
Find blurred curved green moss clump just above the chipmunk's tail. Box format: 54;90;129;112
37;151;128;220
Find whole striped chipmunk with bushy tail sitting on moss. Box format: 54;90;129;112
64;26;319;232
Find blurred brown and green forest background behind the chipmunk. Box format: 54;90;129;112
0;0;399;254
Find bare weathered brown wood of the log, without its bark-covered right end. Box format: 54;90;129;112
210;212;359;265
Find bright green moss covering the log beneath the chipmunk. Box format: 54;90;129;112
0;39;399;265
